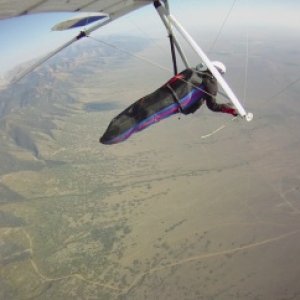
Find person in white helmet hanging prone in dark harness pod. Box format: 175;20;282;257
100;62;238;144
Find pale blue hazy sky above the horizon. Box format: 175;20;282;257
0;0;300;75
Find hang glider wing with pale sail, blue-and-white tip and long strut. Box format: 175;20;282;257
4;0;153;83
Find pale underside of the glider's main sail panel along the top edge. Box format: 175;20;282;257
0;0;153;21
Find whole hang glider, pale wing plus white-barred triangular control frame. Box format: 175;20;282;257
0;0;253;143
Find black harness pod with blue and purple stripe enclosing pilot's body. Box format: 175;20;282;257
100;69;205;145
